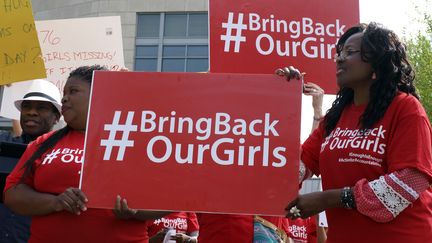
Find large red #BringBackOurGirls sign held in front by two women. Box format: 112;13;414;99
82;72;301;215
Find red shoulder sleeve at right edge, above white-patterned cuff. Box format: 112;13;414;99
387;96;432;178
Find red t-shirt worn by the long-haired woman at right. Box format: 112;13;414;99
302;93;432;243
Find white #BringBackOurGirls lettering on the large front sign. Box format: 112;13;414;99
100;110;287;168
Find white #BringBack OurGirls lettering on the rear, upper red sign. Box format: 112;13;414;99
221;12;345;59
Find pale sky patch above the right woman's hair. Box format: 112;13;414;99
360;0;432;37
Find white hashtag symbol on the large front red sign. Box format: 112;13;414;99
100;111;137;161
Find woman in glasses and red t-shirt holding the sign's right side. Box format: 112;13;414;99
279;23;432;243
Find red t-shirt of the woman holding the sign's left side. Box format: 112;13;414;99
5;131;148;243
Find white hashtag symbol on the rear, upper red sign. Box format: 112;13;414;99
221;12;247;52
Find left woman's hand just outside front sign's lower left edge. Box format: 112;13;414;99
54;187;88;215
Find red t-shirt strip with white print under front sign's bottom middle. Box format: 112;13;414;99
147;212;199;237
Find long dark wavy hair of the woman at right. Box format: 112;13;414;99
324;22;419;136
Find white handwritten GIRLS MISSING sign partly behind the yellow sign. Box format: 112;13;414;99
0;16;124;119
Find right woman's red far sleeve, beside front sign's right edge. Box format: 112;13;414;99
301;121;324;175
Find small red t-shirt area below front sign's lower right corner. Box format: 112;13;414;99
288;217;318;243
